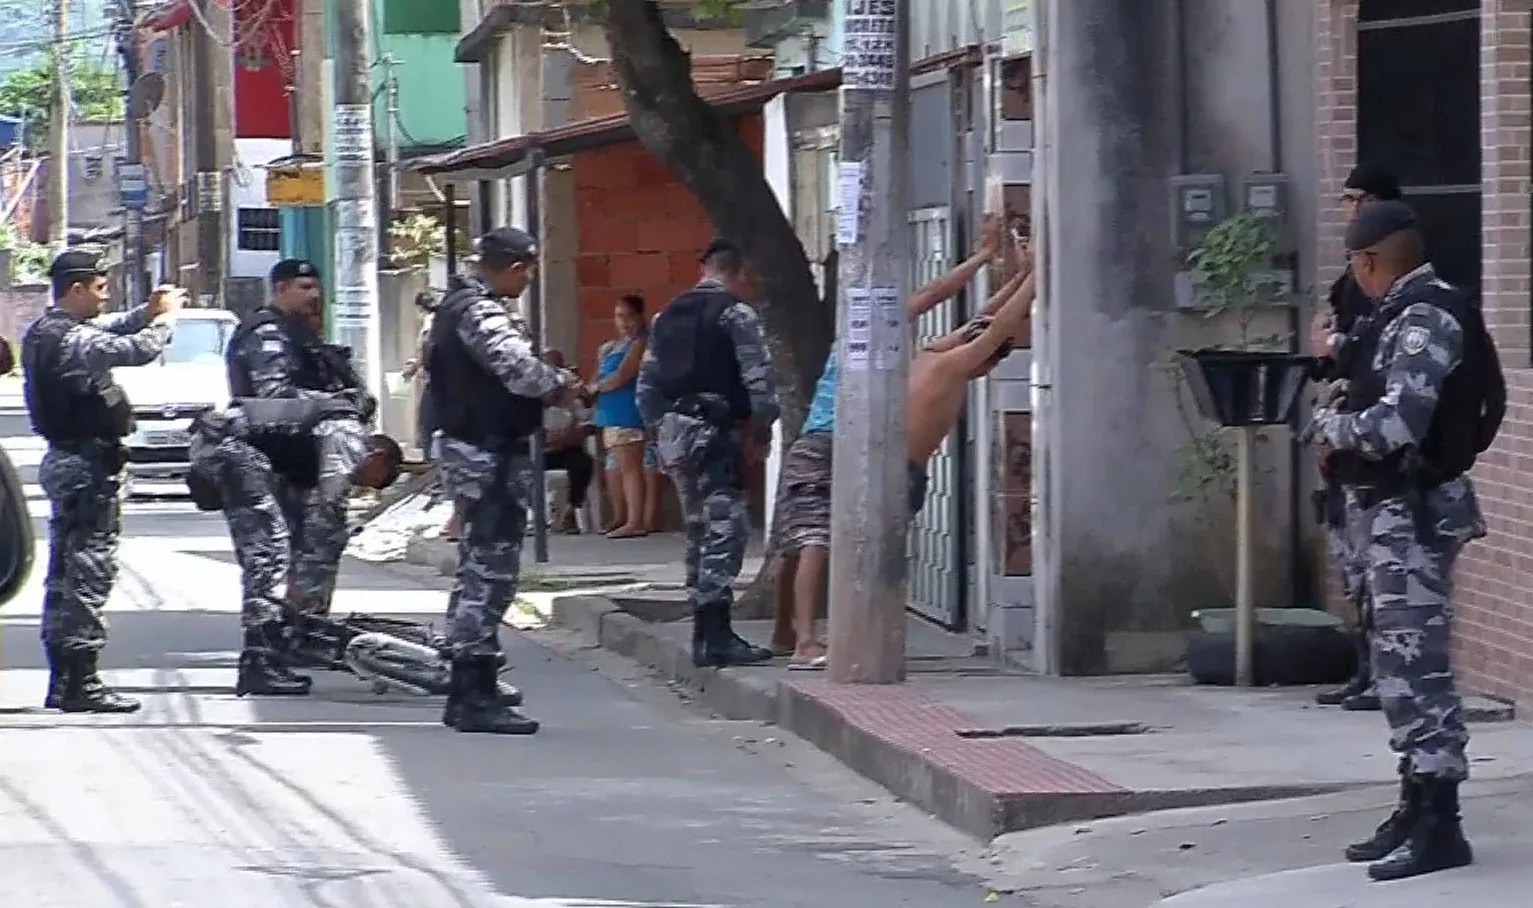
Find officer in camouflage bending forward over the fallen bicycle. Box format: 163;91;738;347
187;396;403;696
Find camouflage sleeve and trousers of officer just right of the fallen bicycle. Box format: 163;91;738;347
438;279;567;660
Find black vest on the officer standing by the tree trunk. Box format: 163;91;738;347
650;288;751;420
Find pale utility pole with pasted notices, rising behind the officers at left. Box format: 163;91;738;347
328;0;382;394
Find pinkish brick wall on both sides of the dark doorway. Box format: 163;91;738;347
1315;0;1533;699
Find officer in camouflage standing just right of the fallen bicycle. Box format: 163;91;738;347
426;227;579;735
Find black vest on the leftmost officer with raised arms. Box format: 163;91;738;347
21;308;133;445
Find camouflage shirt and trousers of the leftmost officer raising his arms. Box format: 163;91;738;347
23;307;172;650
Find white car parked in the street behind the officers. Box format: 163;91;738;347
112;308;239;494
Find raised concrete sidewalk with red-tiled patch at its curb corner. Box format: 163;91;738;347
553;595;1533;839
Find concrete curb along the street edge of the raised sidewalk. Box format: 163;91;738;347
552;595;1363;841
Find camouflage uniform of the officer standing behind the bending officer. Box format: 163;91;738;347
225;314;348;614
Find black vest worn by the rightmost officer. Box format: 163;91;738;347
1334;281;1507;486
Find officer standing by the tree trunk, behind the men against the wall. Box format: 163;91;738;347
636;239;779;666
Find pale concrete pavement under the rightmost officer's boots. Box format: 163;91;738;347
983;779;1533;908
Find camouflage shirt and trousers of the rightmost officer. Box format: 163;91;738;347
1309;265;1485;782
